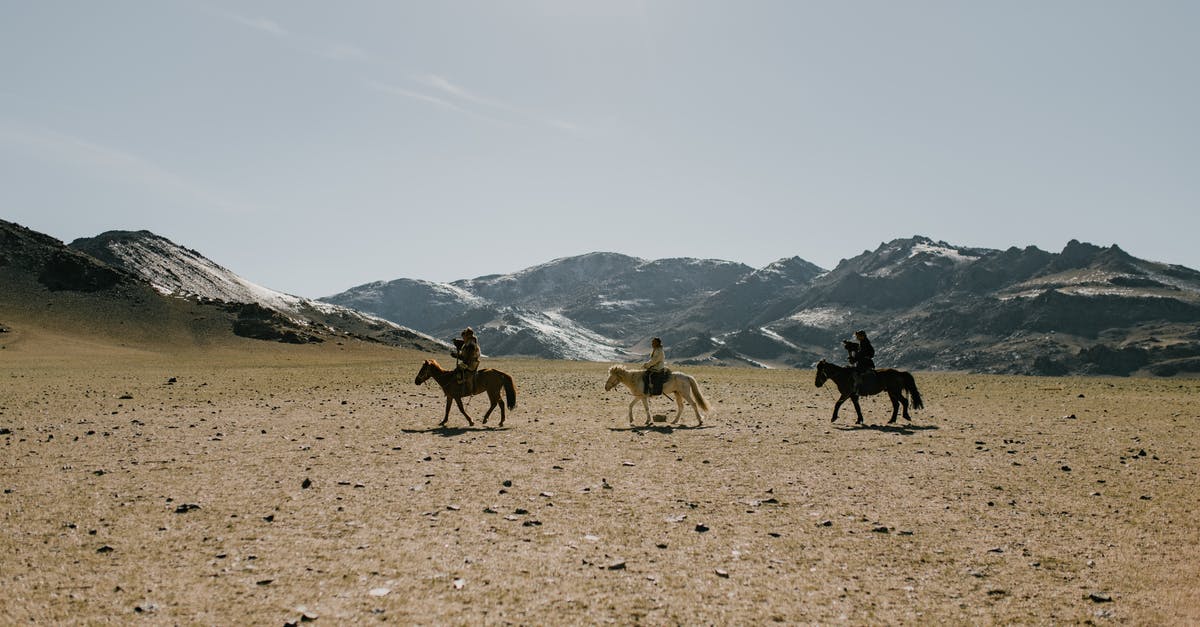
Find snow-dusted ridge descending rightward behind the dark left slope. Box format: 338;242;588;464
70;231;444;348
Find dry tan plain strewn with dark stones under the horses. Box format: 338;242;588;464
0;332;1200;625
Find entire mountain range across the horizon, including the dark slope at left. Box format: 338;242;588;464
0;221;1200;376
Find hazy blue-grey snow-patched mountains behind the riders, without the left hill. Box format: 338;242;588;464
326;235;1200;374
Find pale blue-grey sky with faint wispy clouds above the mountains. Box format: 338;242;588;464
0;0;1200;298
